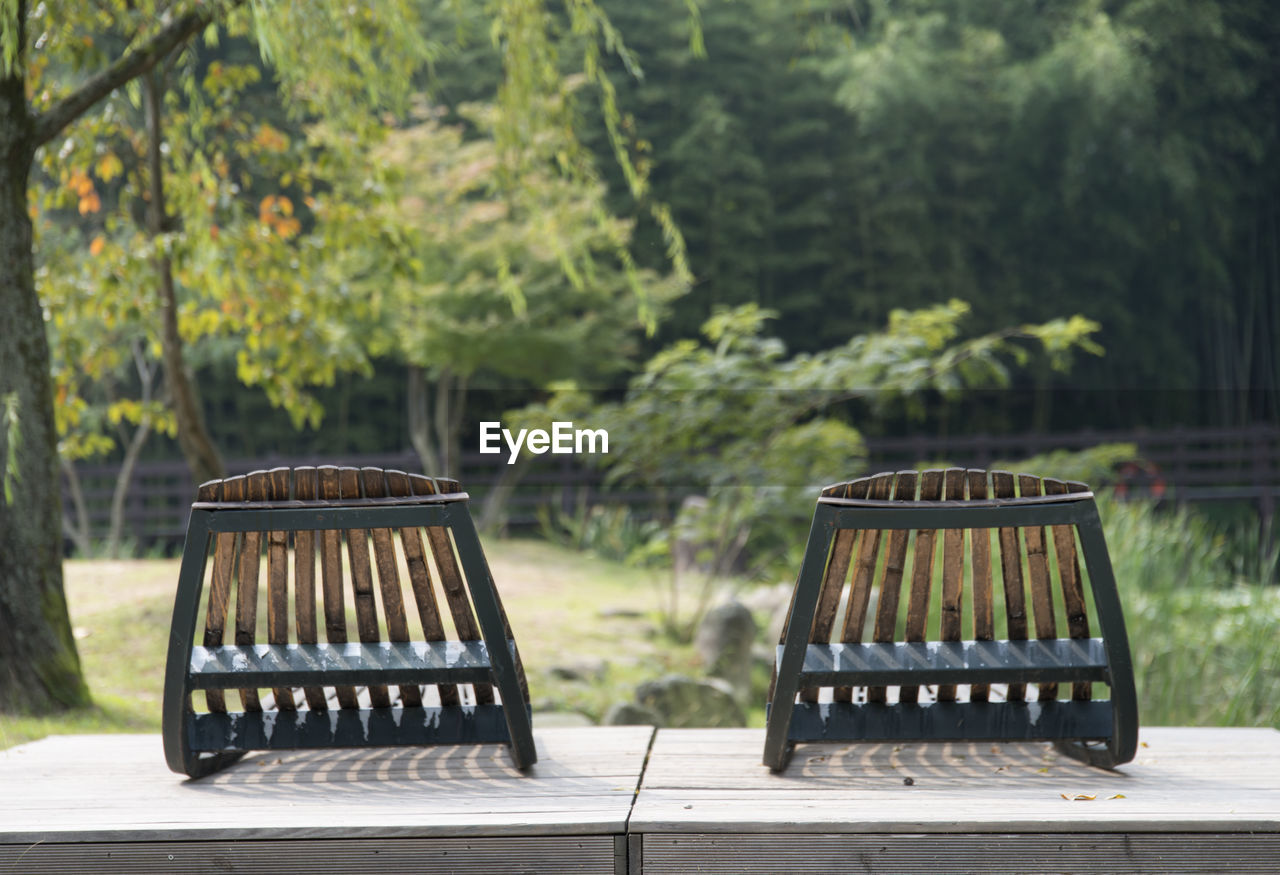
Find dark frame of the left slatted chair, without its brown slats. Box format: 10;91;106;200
163;493;538;778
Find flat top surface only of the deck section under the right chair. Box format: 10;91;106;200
630;728;1280;833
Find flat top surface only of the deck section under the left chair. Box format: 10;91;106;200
0;727;653;844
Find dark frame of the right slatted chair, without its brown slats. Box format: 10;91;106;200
764;491;1138;770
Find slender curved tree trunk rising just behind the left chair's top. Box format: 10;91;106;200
142;72;225;484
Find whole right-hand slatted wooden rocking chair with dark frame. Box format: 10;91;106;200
764;468;1138;770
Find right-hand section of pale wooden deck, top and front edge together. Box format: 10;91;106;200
627;728;1280;875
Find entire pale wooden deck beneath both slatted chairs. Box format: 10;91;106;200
0;727;1280;874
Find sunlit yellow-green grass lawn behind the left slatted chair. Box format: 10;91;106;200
0;539;698;747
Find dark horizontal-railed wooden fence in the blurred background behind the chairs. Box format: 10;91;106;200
63;426;1280;548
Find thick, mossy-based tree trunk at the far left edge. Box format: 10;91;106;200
0;37;90;713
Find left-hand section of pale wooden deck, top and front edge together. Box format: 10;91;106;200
0;727;653;875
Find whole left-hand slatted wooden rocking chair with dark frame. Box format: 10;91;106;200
164;467;536;778
